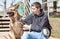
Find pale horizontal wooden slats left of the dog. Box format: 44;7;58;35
0;16;10;32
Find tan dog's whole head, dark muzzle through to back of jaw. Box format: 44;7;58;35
7;7;21;20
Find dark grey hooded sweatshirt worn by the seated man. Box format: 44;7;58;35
24;10;51;32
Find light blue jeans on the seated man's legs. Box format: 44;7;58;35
21;32;48;39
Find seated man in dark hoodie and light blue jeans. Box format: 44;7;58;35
21;2;51;39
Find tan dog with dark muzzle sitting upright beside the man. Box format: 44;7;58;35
7;7;23;39
